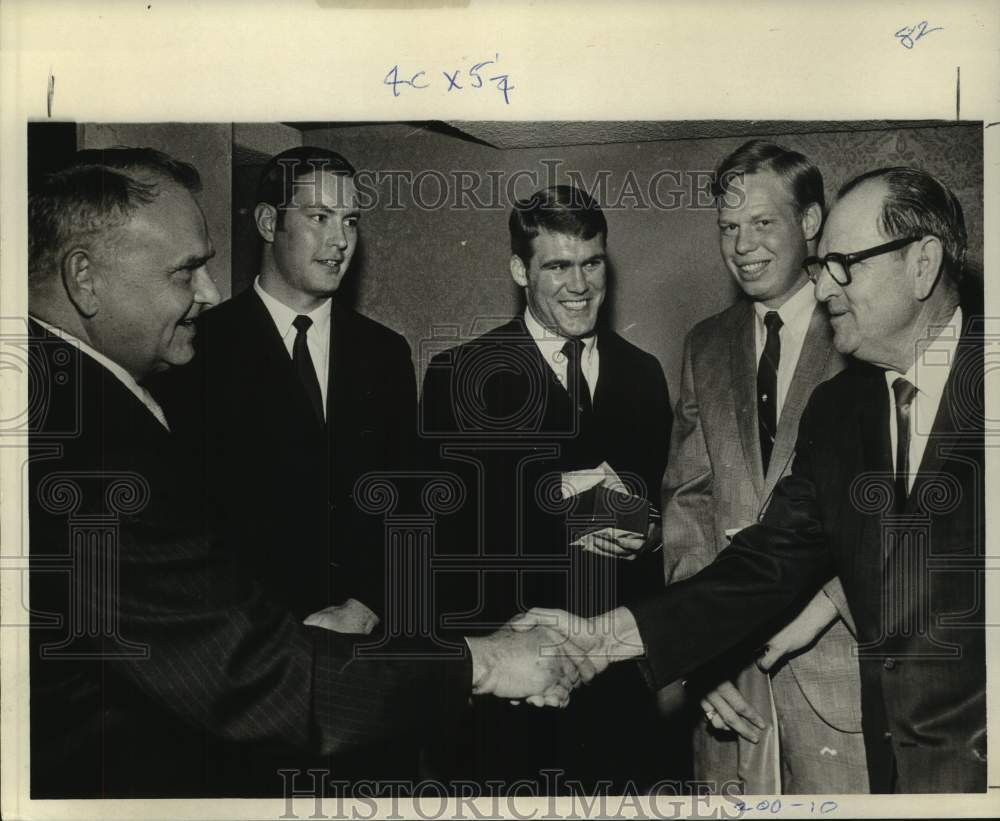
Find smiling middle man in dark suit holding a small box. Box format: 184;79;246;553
421;186;671;789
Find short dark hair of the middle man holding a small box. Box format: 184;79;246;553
509;185;608;265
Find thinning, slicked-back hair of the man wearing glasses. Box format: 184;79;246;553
838;166;968;286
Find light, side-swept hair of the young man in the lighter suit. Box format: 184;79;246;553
712;140;826;213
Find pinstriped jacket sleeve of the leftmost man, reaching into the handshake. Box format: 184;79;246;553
101;519;471;753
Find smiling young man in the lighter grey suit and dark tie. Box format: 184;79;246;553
663;140;868;795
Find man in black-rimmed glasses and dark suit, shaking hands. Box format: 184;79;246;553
526;168;986;793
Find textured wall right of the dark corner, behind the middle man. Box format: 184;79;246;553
304;124;983;393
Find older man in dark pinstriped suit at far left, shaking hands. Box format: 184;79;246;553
25;149;588;798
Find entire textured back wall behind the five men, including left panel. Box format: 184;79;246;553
79;123;983;400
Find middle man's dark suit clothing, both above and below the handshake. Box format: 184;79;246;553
421;318;672;791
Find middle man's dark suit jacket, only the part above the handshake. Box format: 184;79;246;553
420;317;673;627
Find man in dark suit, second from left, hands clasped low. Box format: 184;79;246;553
161;146;408;633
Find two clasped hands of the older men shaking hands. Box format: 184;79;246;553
466;607;643;707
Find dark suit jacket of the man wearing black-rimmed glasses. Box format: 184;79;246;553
632;299;986;793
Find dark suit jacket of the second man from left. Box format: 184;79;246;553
161;288;416;616
